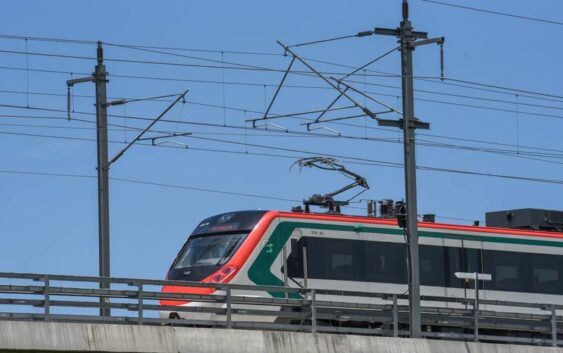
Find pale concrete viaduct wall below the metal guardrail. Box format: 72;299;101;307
0;321;563;353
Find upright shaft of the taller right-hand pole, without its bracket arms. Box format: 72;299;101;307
400;0;421;338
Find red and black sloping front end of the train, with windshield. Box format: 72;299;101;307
160;211;266;320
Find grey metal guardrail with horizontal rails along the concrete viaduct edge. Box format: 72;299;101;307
0;272;563;346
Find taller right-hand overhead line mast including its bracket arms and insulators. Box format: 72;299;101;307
262;0;445;338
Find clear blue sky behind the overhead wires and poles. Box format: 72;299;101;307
0;0;563;278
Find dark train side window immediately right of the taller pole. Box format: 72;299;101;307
419;245;446;287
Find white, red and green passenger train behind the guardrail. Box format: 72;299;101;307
161;210;563;325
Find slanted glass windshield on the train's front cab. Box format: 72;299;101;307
174;233;246;269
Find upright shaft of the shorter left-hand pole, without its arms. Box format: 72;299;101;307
94;42;111;316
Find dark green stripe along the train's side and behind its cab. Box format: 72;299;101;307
248;221;563;298
